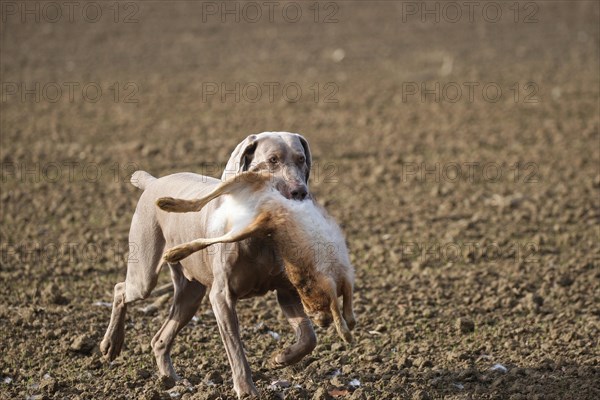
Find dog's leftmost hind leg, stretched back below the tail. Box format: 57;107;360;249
100;211;165;361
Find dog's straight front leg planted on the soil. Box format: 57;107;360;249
209;276;258;398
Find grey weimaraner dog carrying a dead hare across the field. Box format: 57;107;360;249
100;132;317;397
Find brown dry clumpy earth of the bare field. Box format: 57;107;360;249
0;1;600;399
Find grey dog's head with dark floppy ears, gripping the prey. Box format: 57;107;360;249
221;132;312;200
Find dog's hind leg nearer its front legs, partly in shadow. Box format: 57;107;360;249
151;263;206;379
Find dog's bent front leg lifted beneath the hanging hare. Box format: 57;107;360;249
271;289;317;367
